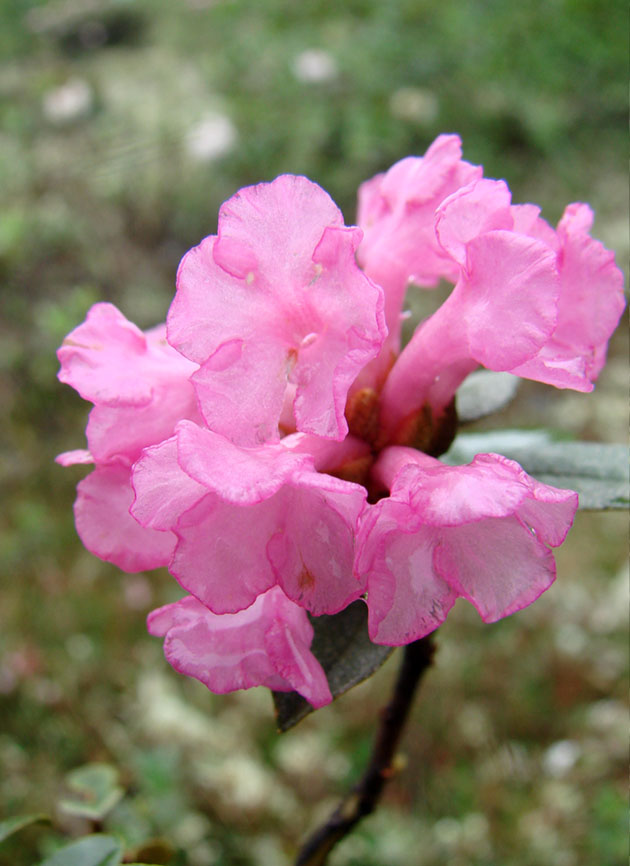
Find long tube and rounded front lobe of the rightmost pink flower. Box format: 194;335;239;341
381;230;559;436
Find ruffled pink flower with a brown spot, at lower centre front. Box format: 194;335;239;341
132;422;367;615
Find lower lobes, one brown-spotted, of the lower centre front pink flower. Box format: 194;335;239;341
171;471;366;615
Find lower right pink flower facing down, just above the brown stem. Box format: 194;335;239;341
356;447;578;645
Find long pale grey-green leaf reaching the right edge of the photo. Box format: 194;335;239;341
442;430;630;511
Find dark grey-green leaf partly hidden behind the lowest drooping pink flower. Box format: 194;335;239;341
273;601;393;731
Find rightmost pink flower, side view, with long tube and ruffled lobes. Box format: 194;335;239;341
381;180;624;441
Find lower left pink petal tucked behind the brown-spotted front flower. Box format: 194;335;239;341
74;465;176;572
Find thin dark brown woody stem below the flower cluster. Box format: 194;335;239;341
295;635;435;866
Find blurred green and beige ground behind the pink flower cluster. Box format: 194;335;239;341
0;0;628;866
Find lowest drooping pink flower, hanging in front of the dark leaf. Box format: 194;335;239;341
147;587;332;708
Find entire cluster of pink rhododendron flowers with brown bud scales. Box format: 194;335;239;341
58;135;623;707
